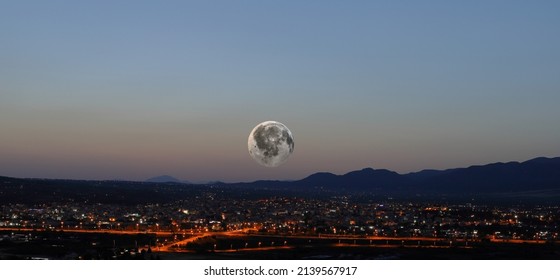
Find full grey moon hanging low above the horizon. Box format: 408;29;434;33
247;121;294;167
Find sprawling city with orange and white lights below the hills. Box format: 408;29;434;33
0;177;560;259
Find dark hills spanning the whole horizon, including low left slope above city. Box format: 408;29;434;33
0;157;560;200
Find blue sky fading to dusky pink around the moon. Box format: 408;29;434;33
0;0;560;181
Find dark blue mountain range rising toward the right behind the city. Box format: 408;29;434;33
226;157;560;194
